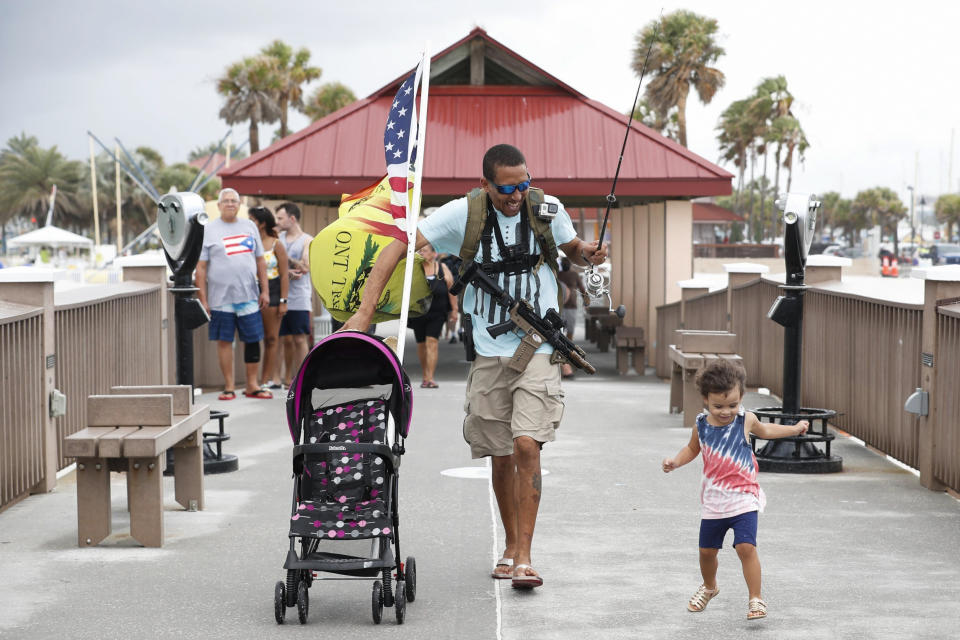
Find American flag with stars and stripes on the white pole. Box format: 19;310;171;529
383;67;419;242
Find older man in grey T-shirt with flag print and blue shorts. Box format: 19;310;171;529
196;189;273;400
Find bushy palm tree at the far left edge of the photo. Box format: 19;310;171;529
0;133;85;229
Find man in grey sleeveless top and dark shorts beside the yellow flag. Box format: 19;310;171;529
277;202;313;387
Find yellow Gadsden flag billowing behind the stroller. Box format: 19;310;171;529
310;177;430;322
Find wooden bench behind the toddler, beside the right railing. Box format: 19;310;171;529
667;329;742;425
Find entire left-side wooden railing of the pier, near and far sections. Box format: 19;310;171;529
0;268;169;510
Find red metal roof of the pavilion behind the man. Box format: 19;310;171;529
221;28;733;198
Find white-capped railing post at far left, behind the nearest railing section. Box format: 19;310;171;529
0;267;66;493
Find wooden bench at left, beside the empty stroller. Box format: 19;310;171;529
63;385;210;547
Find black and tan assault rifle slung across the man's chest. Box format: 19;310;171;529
450;262;597;373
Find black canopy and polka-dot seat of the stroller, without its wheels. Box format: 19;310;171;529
287;331;413;540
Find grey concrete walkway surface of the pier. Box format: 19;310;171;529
0;325;960;640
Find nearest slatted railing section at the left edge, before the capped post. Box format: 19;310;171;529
0;302;45;509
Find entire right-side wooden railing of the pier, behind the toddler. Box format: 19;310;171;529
657;266;960;491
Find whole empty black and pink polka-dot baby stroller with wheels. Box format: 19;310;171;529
274;331;417;624
